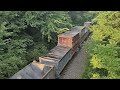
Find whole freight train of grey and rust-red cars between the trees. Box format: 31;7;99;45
10;22;91;79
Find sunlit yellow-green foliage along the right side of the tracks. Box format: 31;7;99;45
83;11;120;79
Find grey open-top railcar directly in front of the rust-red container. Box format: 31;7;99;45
39;46;72;78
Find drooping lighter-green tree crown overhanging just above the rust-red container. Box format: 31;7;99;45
25;11;72;41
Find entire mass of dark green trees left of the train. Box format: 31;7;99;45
0;11;72;78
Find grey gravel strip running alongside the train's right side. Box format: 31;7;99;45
61;48;88;79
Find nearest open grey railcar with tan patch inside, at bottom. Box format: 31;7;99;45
10;61;55;79
